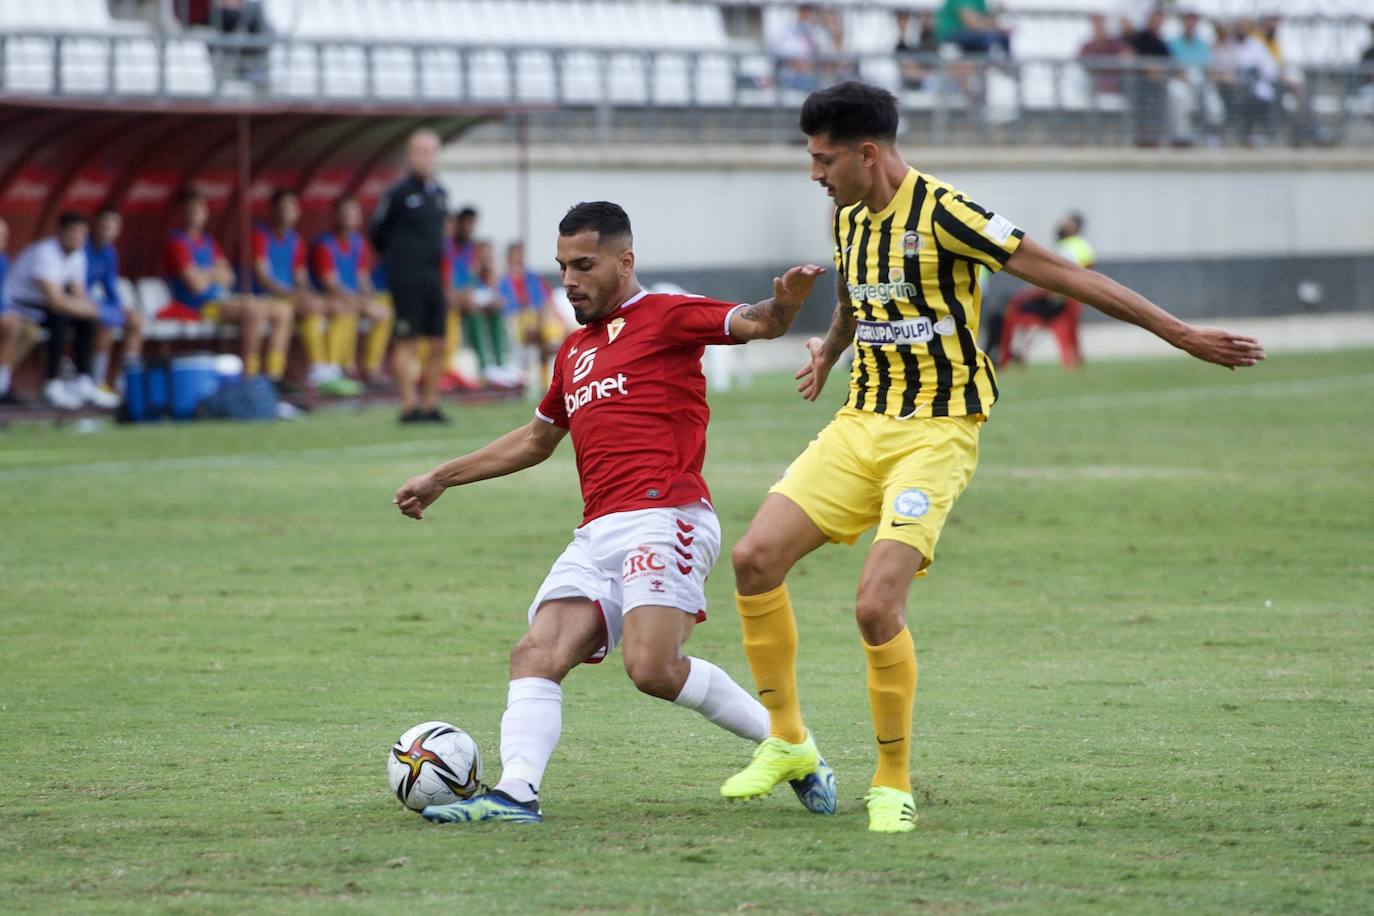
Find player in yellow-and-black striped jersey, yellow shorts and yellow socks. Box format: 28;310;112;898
720;82;1264;832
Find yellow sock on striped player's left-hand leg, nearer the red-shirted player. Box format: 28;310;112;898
735;585;807;744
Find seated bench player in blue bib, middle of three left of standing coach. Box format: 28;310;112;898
253;190;363;397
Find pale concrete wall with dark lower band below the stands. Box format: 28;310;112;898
444;144;1374;335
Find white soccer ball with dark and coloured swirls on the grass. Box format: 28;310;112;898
386;722;482;812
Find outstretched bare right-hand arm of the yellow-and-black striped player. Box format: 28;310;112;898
1006;238;1264;369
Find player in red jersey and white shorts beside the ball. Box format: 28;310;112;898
394;201;835;823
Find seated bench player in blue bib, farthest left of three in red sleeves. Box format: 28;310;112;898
155;190;291;382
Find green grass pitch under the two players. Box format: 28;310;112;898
0;347;1374;913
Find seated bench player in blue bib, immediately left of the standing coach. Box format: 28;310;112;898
311;198;393;386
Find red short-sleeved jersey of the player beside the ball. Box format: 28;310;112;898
534;293;741;525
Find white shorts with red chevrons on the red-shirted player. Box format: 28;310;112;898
529;500;720;663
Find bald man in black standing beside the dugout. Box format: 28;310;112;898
368;130;448;423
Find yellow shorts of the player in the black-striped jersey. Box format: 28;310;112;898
769;407;985;570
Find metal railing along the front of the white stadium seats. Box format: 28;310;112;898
0;32;1374;146
